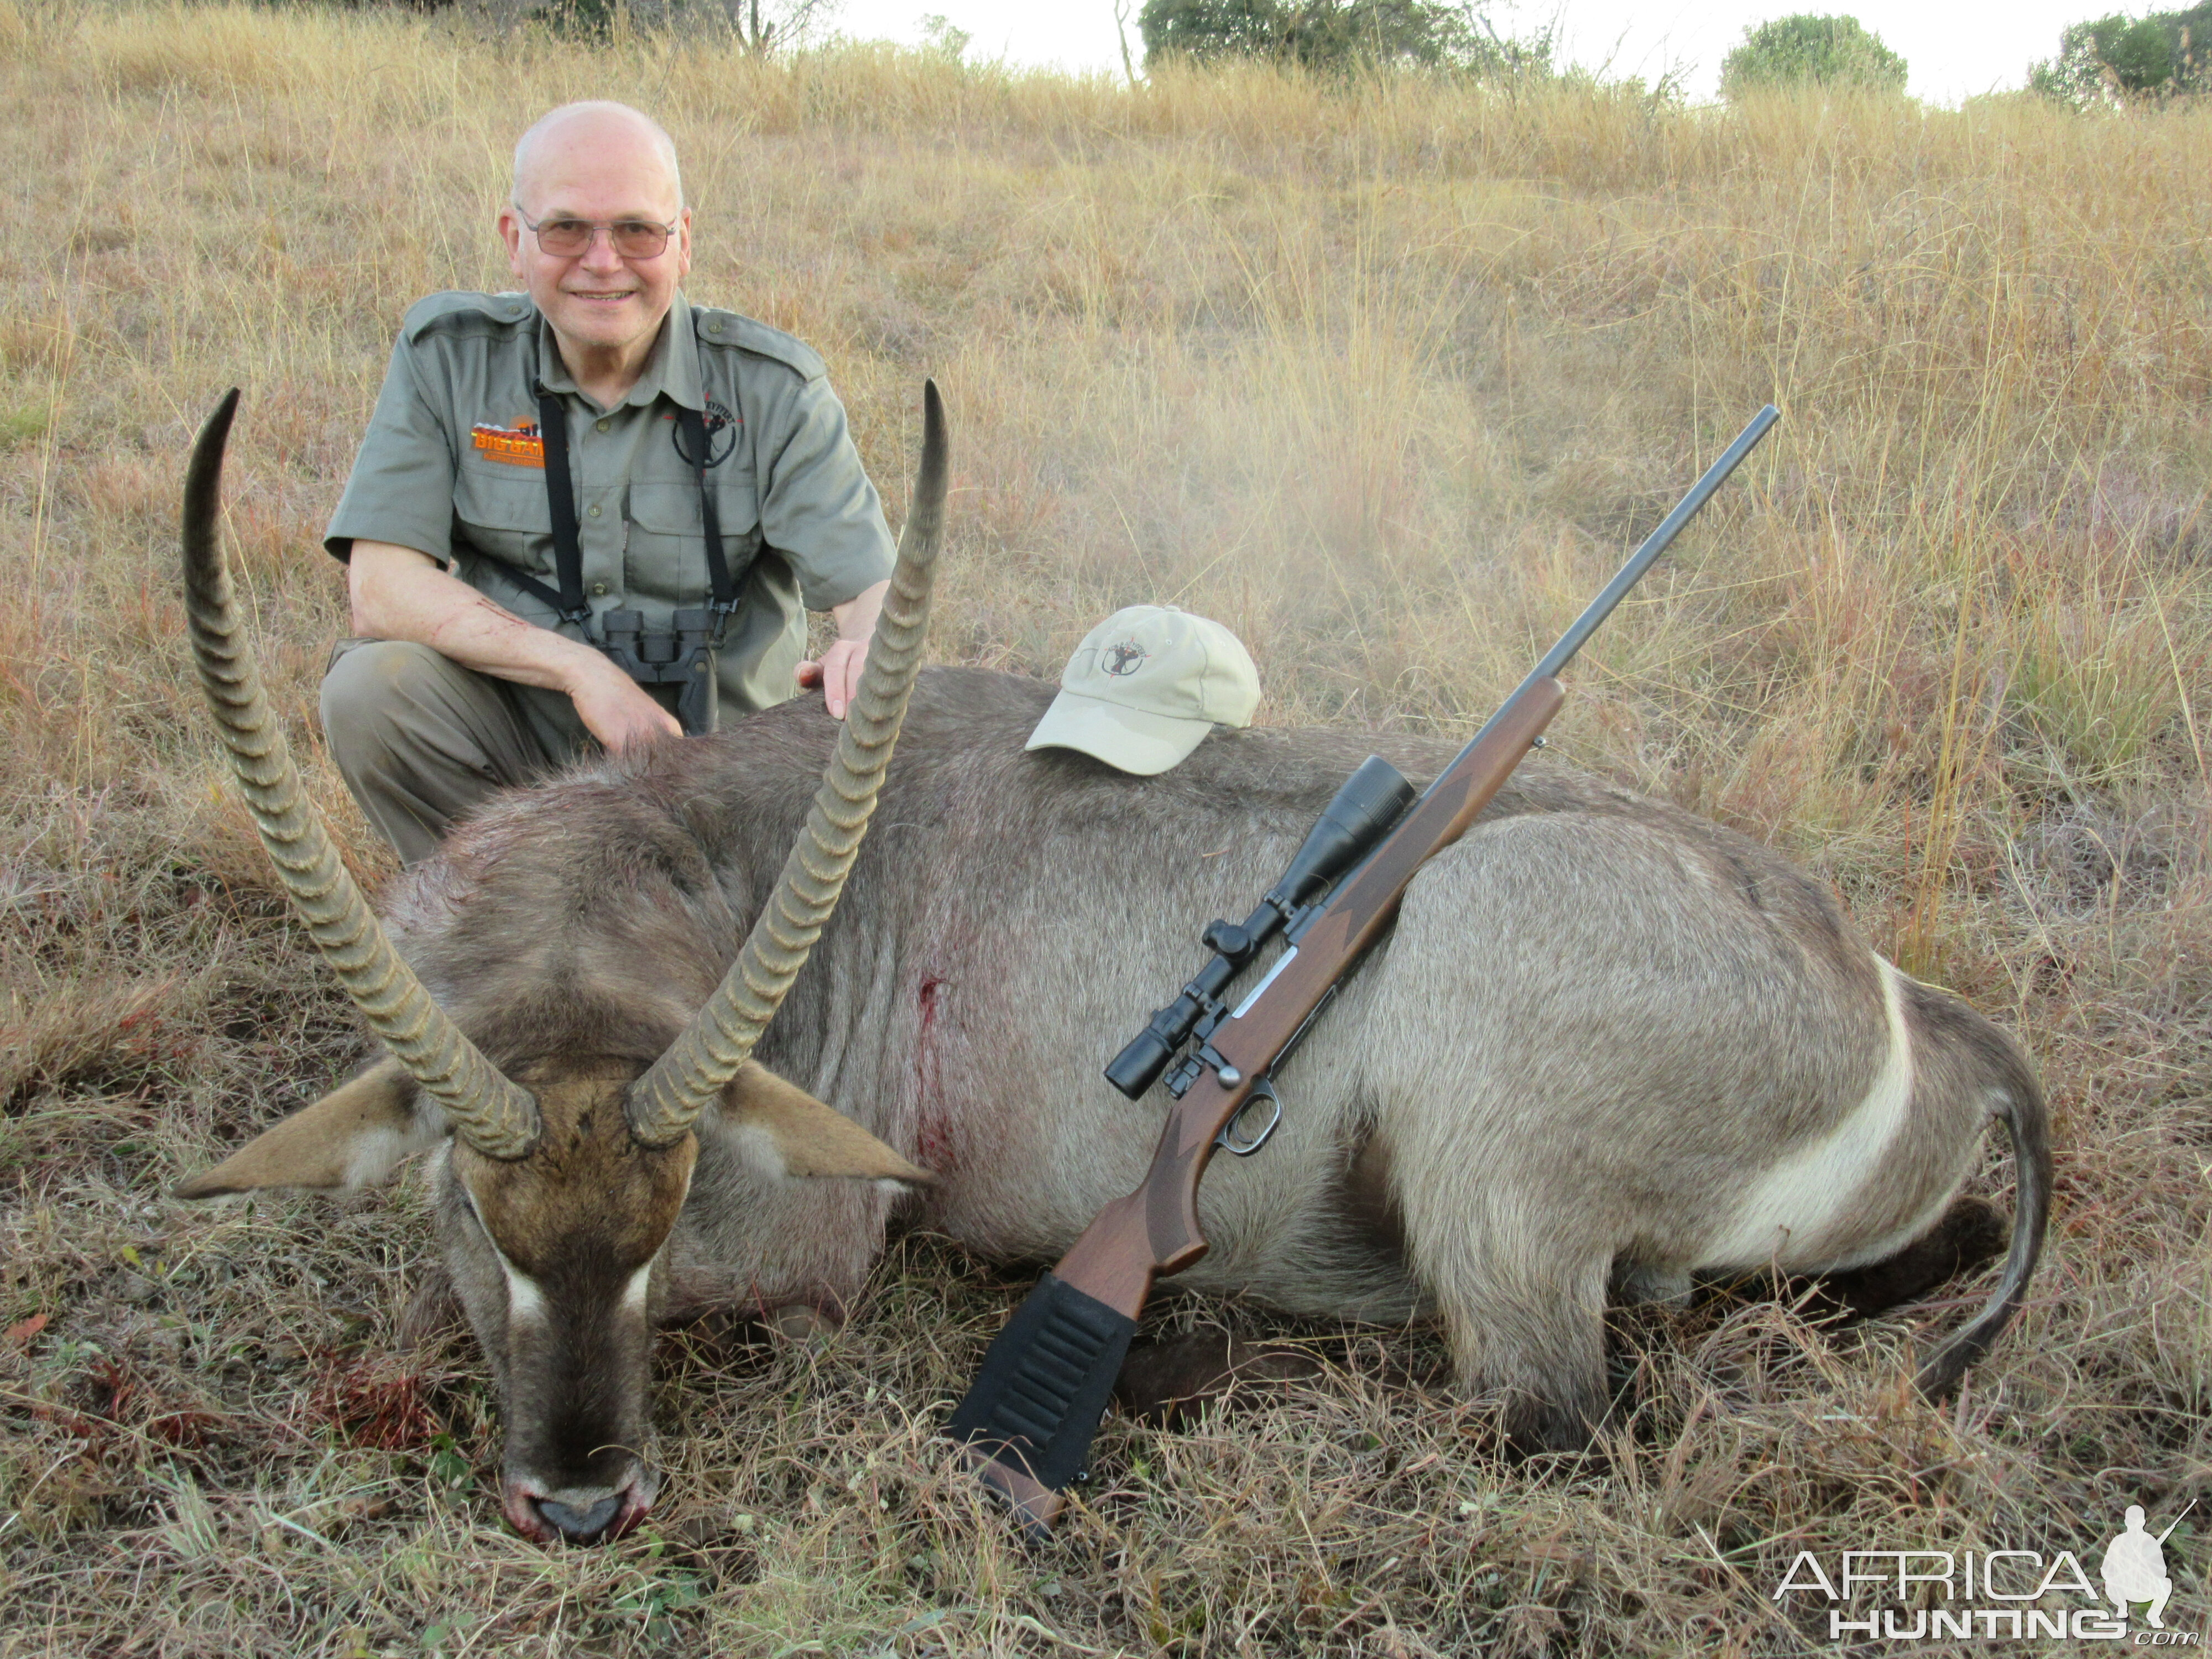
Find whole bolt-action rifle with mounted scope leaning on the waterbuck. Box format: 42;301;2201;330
949;405;1781;1535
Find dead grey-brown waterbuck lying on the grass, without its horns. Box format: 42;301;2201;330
186;400;2051;1537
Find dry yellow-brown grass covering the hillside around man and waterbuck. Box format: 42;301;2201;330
0;0;2212;1659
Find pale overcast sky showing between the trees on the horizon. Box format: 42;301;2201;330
836;0;2088;104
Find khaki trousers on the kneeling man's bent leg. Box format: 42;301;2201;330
323;639;599;865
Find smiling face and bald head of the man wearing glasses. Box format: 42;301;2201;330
500;104;690;372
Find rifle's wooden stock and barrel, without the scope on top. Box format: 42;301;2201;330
949;405;1781;1535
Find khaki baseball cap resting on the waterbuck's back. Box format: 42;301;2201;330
1024;604;1259;776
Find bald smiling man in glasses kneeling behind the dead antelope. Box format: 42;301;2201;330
323;104;894;863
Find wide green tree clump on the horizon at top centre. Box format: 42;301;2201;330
1137;0;1553;73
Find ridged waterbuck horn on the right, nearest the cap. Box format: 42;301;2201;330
630;380;947;1146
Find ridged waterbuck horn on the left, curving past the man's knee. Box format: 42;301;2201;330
184;387;538;1157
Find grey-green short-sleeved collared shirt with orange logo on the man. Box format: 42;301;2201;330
323;292;896;710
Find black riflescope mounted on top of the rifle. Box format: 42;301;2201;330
1106;754;1413;1099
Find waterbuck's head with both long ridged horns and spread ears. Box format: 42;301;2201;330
164;385;947;1542
